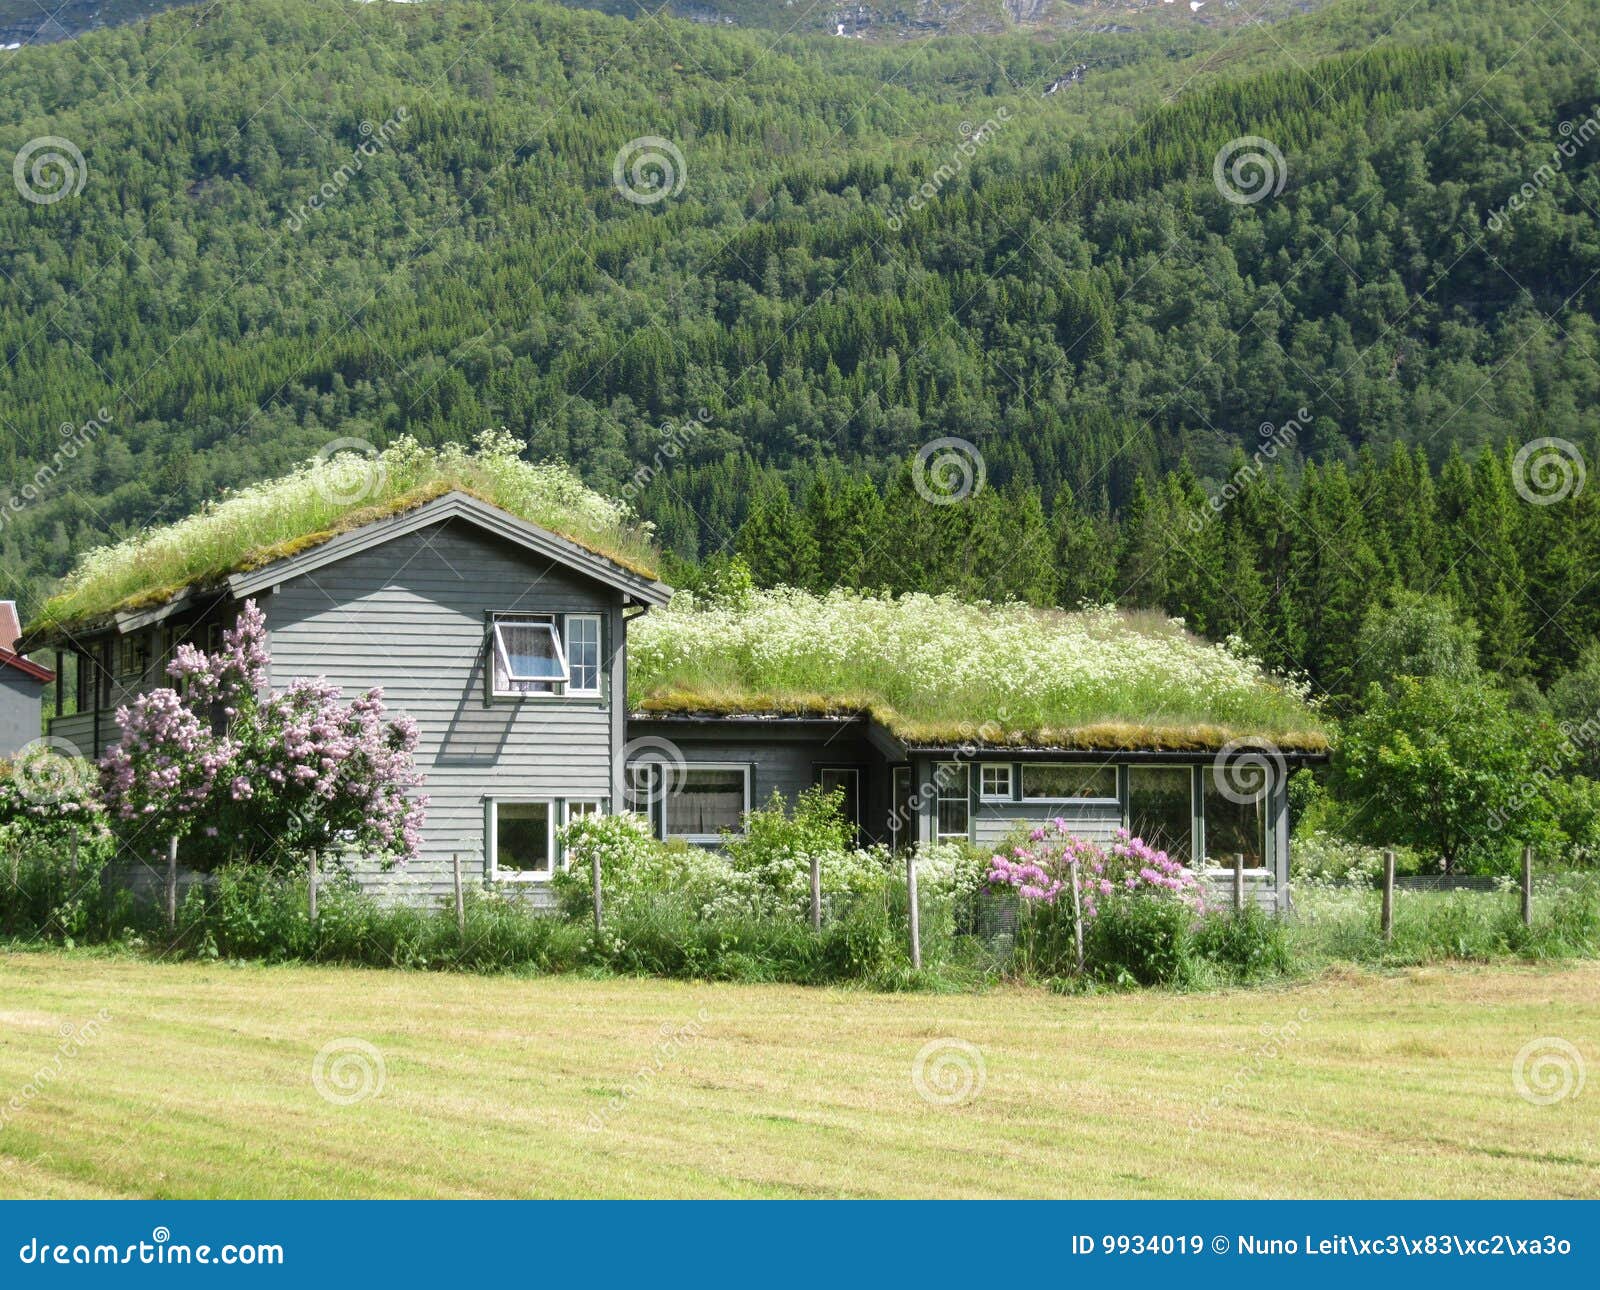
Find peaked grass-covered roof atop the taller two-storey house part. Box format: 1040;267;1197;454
29;431;656;635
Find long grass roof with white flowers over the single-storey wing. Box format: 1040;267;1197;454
627;589;1328;752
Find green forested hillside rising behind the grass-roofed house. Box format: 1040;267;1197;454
0;0;1600;707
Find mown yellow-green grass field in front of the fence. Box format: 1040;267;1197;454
0;954;1600;1197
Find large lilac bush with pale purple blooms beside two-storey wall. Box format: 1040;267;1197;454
101;600;427;867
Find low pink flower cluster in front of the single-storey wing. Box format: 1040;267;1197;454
987;819;1203;919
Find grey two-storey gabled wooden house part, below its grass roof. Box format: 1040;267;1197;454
30;491;669;898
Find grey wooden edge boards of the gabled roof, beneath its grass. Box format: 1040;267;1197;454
24;490;672;648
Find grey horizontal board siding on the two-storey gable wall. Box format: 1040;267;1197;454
261;522;624;901
